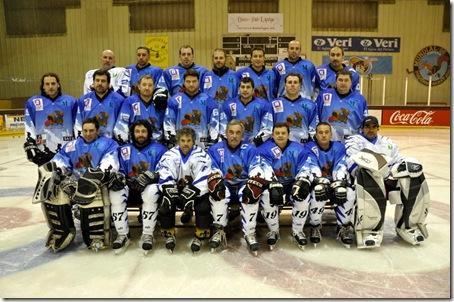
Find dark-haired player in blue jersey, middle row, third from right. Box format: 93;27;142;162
220;77;273;146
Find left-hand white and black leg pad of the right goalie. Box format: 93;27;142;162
355;168;386;246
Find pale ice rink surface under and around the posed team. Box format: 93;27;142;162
0;128;451;298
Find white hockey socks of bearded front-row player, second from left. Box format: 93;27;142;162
109;184;160;235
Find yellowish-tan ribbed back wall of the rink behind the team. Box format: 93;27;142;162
0;0;451;106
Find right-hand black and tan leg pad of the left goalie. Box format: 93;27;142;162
79;186;111;251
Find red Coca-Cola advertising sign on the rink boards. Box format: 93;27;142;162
382;109;450;126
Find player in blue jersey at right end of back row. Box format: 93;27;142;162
317;46;360;91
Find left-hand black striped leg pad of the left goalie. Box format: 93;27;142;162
42;202;76;252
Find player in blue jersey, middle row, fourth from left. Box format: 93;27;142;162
163;69;219;148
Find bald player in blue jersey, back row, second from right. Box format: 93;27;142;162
273;40;319;99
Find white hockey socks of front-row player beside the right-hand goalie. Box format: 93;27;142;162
309;187;356;226
